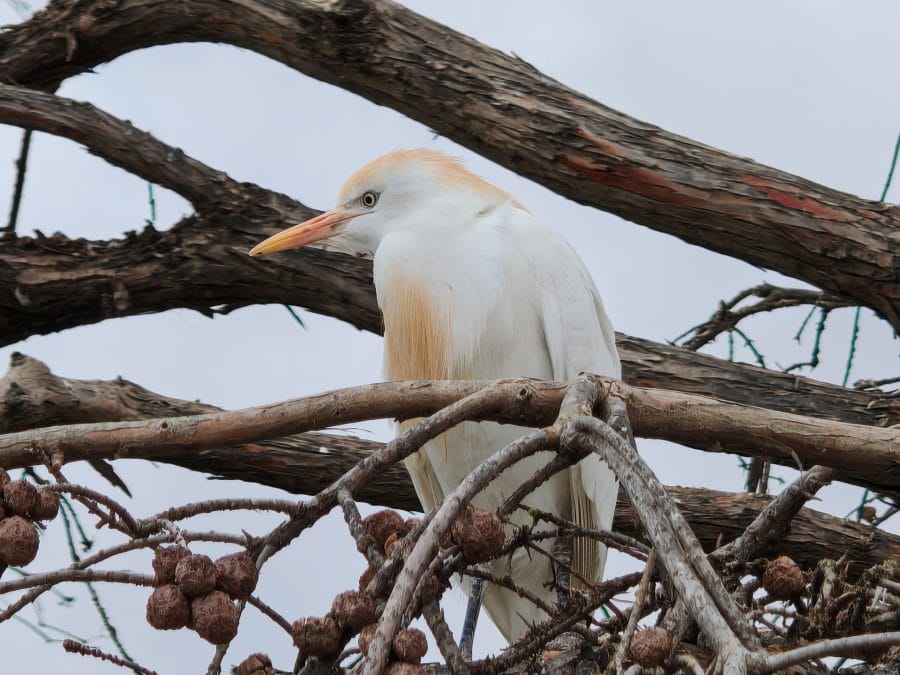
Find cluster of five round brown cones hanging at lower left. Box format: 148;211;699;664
147;545;256;644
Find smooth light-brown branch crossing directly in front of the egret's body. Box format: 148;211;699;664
0;370;900;493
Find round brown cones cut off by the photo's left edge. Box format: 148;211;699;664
0;469;59;567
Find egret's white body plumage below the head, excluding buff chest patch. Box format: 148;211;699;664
375;177;620;640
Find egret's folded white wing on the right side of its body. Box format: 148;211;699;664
538;230;621;587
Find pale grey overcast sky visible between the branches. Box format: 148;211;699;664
0;0;900;673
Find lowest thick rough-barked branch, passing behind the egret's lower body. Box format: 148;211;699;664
0;355;900;577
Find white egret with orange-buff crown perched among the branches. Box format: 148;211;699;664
250;149;621;642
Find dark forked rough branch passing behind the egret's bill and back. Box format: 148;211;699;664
0;85;900;438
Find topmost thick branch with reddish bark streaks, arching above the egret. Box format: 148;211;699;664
0;0;900;329
